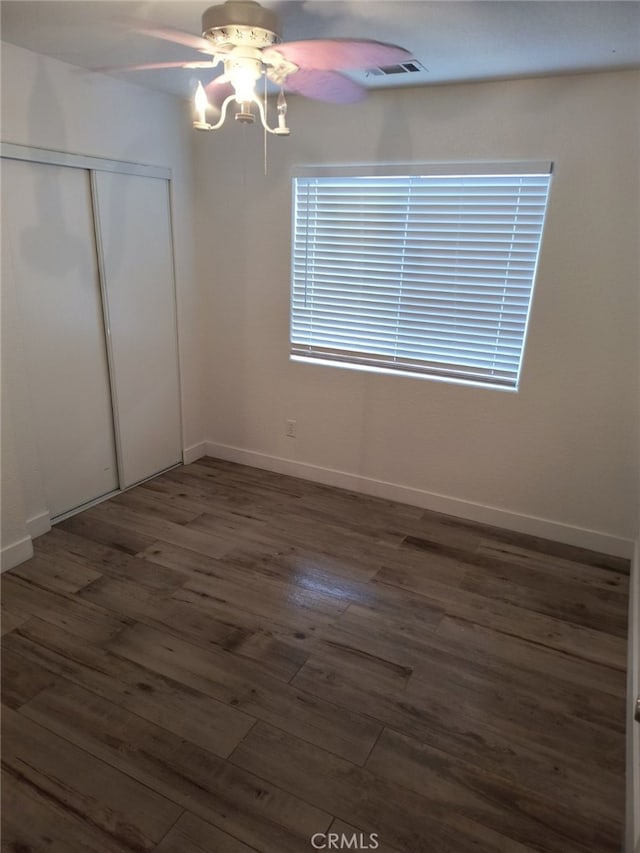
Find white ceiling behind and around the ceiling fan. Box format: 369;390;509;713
0;0;640;95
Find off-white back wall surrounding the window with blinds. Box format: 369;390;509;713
195;72;640;555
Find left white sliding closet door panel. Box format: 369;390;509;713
2;160;118;518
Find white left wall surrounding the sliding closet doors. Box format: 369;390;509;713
0;44;204;568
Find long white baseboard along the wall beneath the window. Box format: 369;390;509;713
204;441;634;559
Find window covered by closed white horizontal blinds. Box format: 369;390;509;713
291;163;551;388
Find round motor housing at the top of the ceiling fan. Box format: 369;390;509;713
202;0;281;49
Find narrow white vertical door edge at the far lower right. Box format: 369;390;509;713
624;540;640;853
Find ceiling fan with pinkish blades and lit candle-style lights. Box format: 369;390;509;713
112;0;411;136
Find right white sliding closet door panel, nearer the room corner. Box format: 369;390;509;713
93;172;182;488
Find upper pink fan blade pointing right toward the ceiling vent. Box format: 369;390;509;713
262;39;411;71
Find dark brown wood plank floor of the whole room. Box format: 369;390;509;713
2;459;628;853
